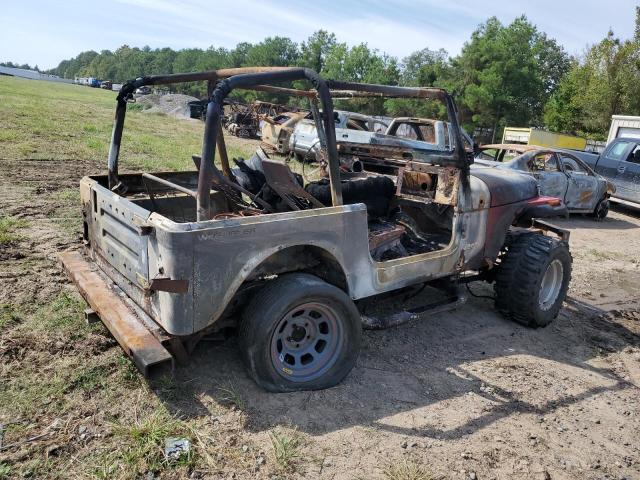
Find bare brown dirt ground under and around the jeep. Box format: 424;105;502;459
0;148;640;479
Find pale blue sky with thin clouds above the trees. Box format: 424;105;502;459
0;0;640;69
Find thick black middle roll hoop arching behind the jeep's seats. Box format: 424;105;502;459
196;68;342;221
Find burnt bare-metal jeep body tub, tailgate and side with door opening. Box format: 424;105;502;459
81;172;490;336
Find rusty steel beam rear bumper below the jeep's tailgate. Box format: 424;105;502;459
59;252;173;377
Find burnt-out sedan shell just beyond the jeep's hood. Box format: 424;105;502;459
475;144;616;219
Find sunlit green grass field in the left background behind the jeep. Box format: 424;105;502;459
0;77;252;170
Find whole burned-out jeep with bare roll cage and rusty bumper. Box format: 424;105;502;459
61;67;571;392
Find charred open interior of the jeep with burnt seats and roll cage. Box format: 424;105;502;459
100;69;462;261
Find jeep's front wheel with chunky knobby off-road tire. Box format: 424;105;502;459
494;233;572;328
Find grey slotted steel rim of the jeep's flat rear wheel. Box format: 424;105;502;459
271;302;343;382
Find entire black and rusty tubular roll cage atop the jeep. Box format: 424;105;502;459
108;67;469;221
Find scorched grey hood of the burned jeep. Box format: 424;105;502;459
471;166;538;207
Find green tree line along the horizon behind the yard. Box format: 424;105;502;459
41;7;640;140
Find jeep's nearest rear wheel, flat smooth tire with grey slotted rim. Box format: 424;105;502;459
239;274;362;392
